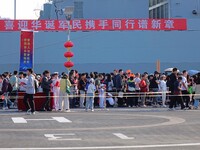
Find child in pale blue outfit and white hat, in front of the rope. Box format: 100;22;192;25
86;78;96;111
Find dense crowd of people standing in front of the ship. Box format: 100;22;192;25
0;68;200;114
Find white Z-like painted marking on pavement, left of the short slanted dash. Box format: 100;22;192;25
44;133;82;141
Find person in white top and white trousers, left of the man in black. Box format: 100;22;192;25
159;75;167;108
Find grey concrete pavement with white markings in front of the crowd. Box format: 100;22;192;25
0;108;200;150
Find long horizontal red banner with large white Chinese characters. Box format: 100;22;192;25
0;19;187;31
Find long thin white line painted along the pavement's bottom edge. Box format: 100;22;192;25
0;143;200;150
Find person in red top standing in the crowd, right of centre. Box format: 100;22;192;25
139;74;148;107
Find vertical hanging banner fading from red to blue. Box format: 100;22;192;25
19;31;33;72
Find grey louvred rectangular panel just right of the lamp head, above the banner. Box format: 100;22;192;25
74;1;83;19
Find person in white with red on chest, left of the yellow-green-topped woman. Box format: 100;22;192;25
52;72;60;111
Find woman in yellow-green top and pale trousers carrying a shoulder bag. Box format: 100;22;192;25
59;74;71;112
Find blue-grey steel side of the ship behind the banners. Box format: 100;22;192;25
0;0;200;72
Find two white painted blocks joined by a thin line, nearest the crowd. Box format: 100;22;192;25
12;117;72;123
